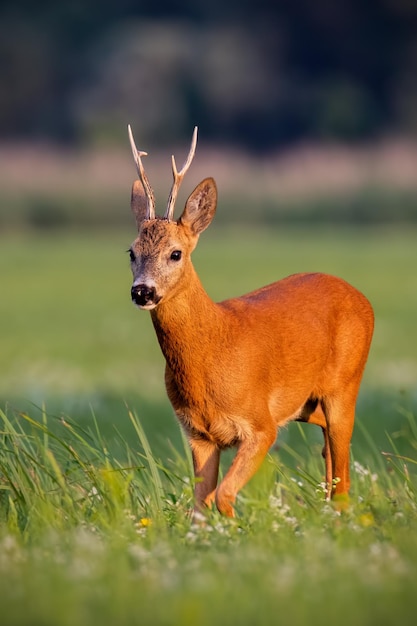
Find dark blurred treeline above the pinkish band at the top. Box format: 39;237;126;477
0;0;417;150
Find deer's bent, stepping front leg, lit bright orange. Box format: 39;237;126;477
216;428;276;517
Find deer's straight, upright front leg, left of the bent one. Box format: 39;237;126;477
190;439;220;511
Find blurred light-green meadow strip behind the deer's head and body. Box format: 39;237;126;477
0;225;417;392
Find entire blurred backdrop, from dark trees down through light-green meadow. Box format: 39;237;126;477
0;0;417;450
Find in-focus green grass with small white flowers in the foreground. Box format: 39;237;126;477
0;402;417;626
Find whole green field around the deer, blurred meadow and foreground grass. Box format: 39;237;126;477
0;225;417;626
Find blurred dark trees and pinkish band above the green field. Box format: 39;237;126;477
0;0;417;229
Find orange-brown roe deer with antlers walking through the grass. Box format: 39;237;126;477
129;126;374;516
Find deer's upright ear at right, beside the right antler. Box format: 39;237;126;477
178;178;217;235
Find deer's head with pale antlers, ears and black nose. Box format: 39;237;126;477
129;126;217;310
